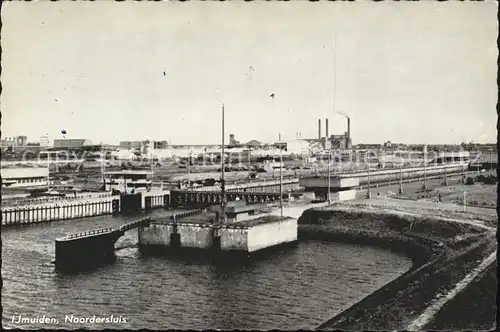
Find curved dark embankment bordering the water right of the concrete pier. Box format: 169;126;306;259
299;206;496;330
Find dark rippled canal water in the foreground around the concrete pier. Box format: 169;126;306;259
2;211;411;330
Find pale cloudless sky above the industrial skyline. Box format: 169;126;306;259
0;1;498;144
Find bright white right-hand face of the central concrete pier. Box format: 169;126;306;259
248;218;297;252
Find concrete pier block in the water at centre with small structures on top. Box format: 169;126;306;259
139;202;298;255
